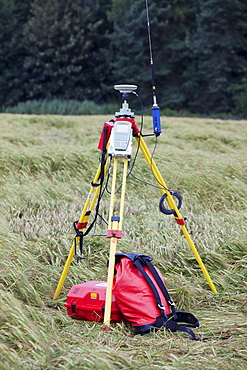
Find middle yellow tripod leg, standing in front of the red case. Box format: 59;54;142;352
104;158;128;327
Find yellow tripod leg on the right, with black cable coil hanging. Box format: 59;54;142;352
136;134;217;293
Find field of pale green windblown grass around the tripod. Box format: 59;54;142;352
0;114;247;370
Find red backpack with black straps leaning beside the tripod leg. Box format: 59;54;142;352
112;253;199;340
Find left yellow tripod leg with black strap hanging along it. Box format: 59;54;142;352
53;159;109;300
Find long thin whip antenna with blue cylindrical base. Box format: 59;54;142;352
146;0;162;136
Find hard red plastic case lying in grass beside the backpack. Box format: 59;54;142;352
64;281;123;323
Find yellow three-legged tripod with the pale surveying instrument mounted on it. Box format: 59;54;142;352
53;85;217;327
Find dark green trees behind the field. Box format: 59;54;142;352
0;0;247;116
